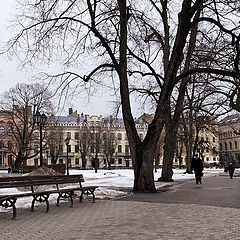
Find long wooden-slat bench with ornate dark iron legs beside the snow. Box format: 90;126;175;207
0;174;97;219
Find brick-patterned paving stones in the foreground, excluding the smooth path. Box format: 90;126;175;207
0;200;240;240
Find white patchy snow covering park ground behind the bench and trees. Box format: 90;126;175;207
0;168;227;212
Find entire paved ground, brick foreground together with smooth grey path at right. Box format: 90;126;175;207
0;172;240;240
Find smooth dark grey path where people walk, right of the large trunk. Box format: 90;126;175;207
124;172;240;208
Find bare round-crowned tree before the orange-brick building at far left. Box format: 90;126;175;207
1;84;51;168
